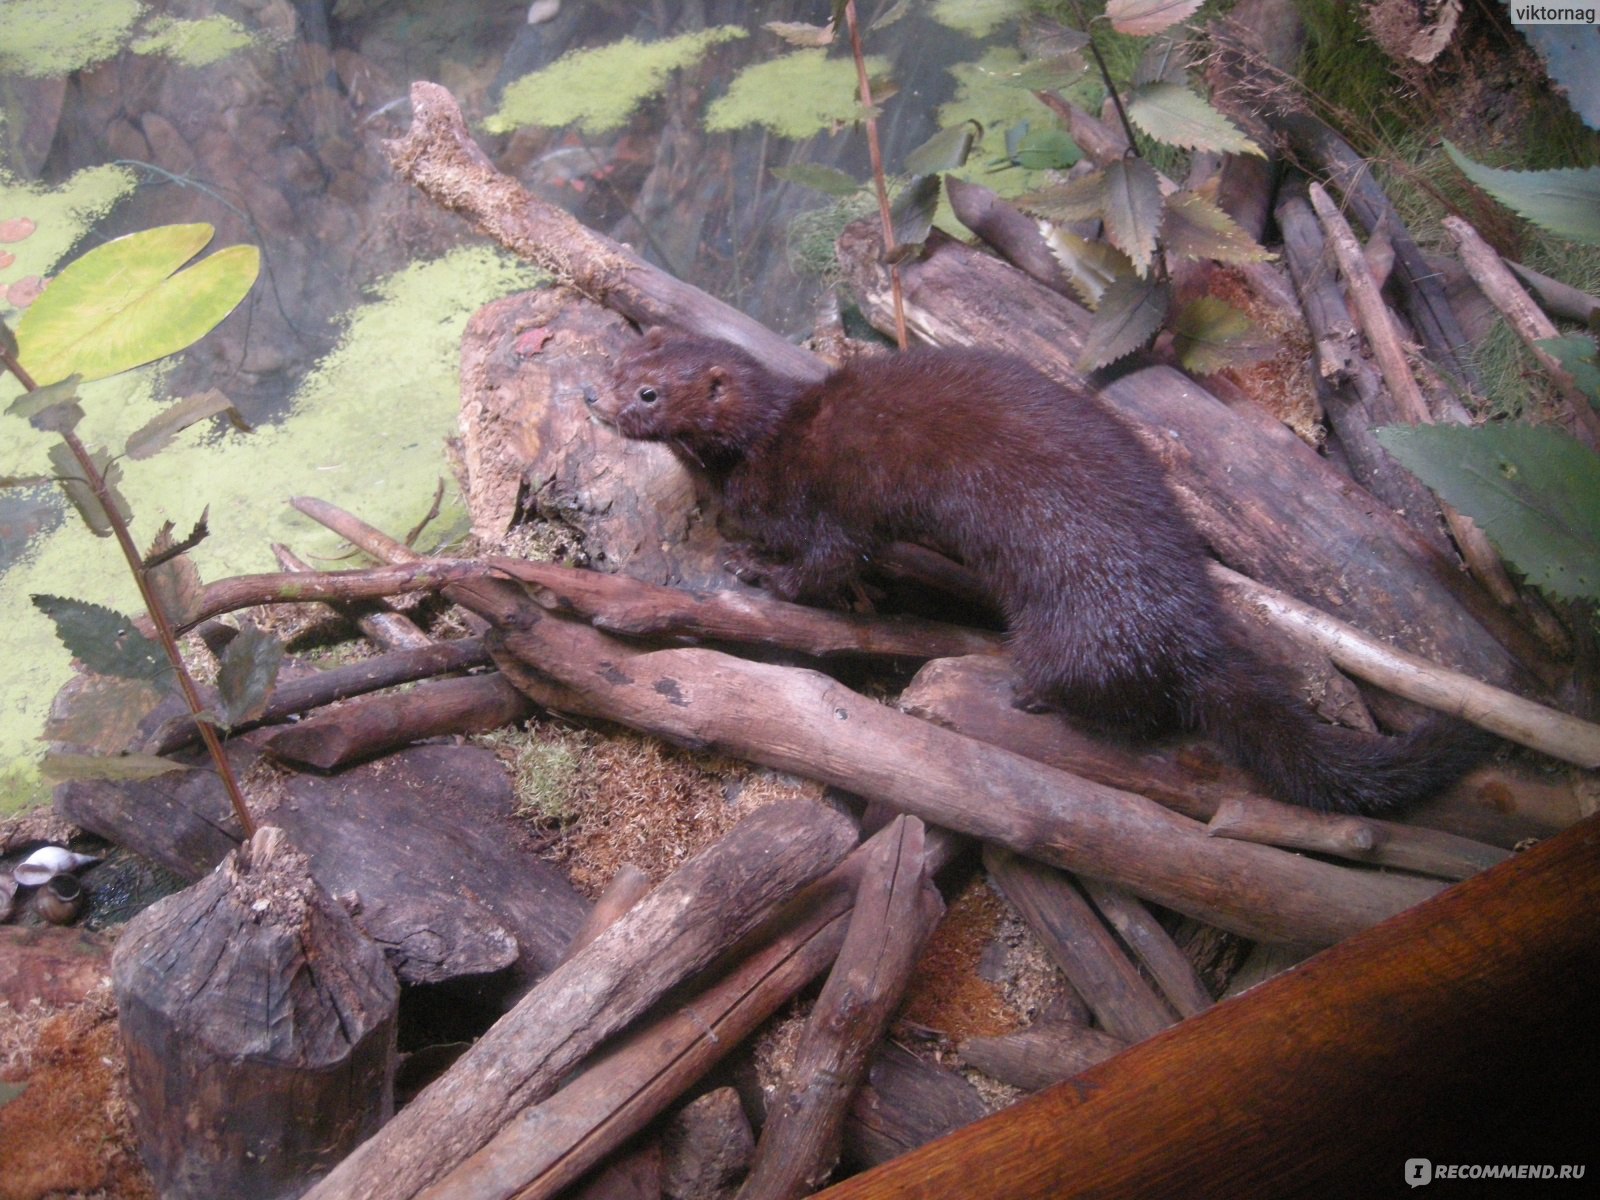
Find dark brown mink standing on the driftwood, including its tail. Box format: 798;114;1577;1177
590;330;1486;813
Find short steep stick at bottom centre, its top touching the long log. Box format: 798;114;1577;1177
739;816;944;1200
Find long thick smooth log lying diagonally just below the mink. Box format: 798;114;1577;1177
494;614;1435;944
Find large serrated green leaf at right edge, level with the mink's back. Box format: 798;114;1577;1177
1378;424;1600;600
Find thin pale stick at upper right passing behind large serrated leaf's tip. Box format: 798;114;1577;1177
1310;184;1518;608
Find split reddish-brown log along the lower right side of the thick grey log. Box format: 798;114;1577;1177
418;830;957;1200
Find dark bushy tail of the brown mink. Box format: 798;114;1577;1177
1197;656;1496;814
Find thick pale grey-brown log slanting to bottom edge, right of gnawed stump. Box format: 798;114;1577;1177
309;803;854;1200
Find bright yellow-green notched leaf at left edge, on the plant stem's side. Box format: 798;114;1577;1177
16;224;261;384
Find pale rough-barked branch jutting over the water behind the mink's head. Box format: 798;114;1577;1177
384;83;827;379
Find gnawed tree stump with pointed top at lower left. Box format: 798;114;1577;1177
112;827;400;1200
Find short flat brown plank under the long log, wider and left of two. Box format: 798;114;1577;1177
984;846;1176;1042
